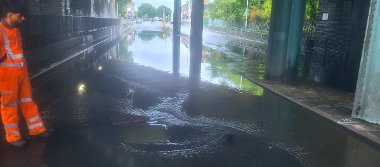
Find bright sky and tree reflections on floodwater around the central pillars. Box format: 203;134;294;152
118;31;265;95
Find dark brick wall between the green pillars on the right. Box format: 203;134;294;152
307;0;370;91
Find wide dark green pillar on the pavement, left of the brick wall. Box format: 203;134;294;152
265;0;306;82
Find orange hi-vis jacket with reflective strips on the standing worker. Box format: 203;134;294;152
0;20;26;69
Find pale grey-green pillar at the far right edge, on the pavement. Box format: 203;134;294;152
352;0;380;124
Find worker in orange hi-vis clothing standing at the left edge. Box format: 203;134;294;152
0;0;46;147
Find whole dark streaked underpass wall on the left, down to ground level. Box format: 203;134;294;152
15;0;121;78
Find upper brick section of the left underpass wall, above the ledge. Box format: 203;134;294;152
22;0;119;50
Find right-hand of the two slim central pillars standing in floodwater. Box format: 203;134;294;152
189;0;204;83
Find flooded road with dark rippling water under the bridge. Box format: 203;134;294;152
0;25;380;167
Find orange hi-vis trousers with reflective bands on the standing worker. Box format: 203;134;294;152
0;67;46;142
